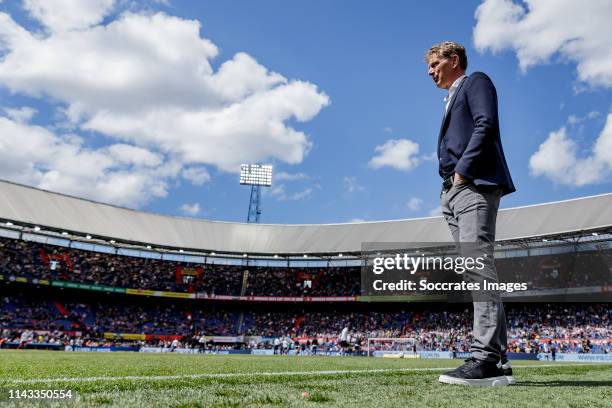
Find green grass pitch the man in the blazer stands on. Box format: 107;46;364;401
0;350;612;408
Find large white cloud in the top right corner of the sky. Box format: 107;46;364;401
474;0;612;87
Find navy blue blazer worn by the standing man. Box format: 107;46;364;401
438;72;516;195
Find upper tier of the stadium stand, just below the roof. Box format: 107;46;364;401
0;238;612;297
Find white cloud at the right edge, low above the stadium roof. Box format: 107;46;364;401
529;114;612;186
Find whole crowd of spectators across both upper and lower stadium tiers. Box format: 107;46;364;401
0;238;612;352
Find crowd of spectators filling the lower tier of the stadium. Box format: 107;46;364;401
0;290;612;353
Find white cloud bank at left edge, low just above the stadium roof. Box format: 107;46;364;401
0;117;178;207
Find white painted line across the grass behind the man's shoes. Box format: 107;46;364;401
0;362;606;385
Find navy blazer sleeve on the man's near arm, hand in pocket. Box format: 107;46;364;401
455;72;499;179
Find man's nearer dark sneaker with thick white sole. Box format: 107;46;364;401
438;357;508;387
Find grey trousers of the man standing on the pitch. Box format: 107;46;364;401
440;183;508;362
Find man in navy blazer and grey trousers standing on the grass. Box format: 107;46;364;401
425;42;516;386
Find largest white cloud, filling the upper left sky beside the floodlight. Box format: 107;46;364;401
0;4;330;205
